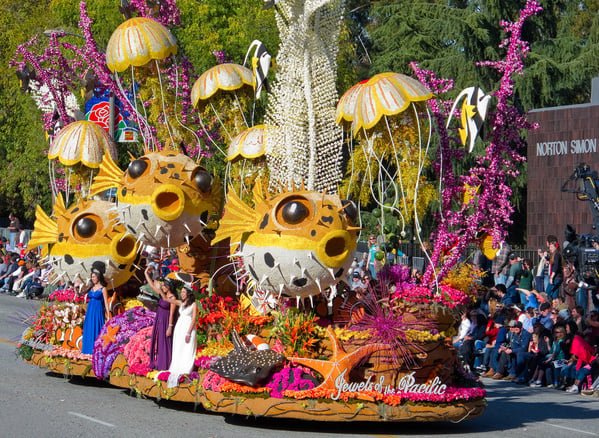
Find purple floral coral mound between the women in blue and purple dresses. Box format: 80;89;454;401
92;307;156;379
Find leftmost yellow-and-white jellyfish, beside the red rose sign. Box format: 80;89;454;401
48;120;117;197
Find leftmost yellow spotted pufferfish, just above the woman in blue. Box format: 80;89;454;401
29;194;140;289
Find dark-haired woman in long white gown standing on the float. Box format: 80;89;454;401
168;285;198;388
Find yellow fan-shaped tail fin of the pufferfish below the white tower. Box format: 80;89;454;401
212;188;257;248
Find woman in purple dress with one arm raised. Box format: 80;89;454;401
145;266;177;370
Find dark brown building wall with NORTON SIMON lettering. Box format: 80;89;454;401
527;95;599;248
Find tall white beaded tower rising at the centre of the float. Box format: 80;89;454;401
266;0;344;192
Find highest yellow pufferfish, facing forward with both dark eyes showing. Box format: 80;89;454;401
91;150;220;248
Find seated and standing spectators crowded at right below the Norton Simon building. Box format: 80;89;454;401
466;236;599;397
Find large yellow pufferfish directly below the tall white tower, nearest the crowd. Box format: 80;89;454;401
213;184;360;301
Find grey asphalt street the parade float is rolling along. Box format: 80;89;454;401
0;295;599;438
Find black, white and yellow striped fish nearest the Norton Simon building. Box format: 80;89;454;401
446;87;491;152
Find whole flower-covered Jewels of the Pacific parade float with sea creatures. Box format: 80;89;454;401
13;0;539;421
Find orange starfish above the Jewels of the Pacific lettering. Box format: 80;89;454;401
287;326;389;389
